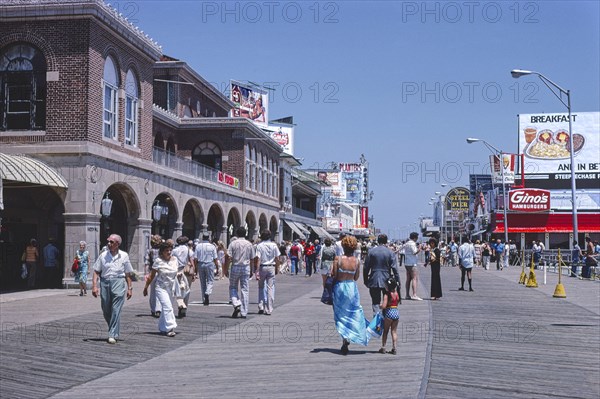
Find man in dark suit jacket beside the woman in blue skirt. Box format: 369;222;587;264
363;234;400;316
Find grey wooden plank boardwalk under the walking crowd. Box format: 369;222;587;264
0;268;600;398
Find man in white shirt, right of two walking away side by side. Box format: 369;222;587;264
254;229;281;316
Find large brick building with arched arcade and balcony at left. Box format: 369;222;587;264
0;0;281;289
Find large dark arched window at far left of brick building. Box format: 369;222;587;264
0;43;46;130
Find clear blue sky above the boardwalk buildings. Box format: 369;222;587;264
125;1;600;237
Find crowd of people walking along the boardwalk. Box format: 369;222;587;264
81;227;600;354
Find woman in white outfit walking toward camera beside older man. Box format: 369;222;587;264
144;240;179;337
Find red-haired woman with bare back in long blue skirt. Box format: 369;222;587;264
331;236;370;355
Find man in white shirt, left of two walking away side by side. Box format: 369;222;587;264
225;227;256;319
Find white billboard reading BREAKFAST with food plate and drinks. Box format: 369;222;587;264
519;112;600;189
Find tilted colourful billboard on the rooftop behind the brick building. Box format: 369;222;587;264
229;80;269;126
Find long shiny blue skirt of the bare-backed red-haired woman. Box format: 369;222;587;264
333;280;370;346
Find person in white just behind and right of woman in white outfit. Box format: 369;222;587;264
171;236;196;318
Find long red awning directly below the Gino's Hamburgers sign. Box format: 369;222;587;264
494;213;600;233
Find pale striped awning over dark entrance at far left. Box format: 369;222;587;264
0;153;69;188
